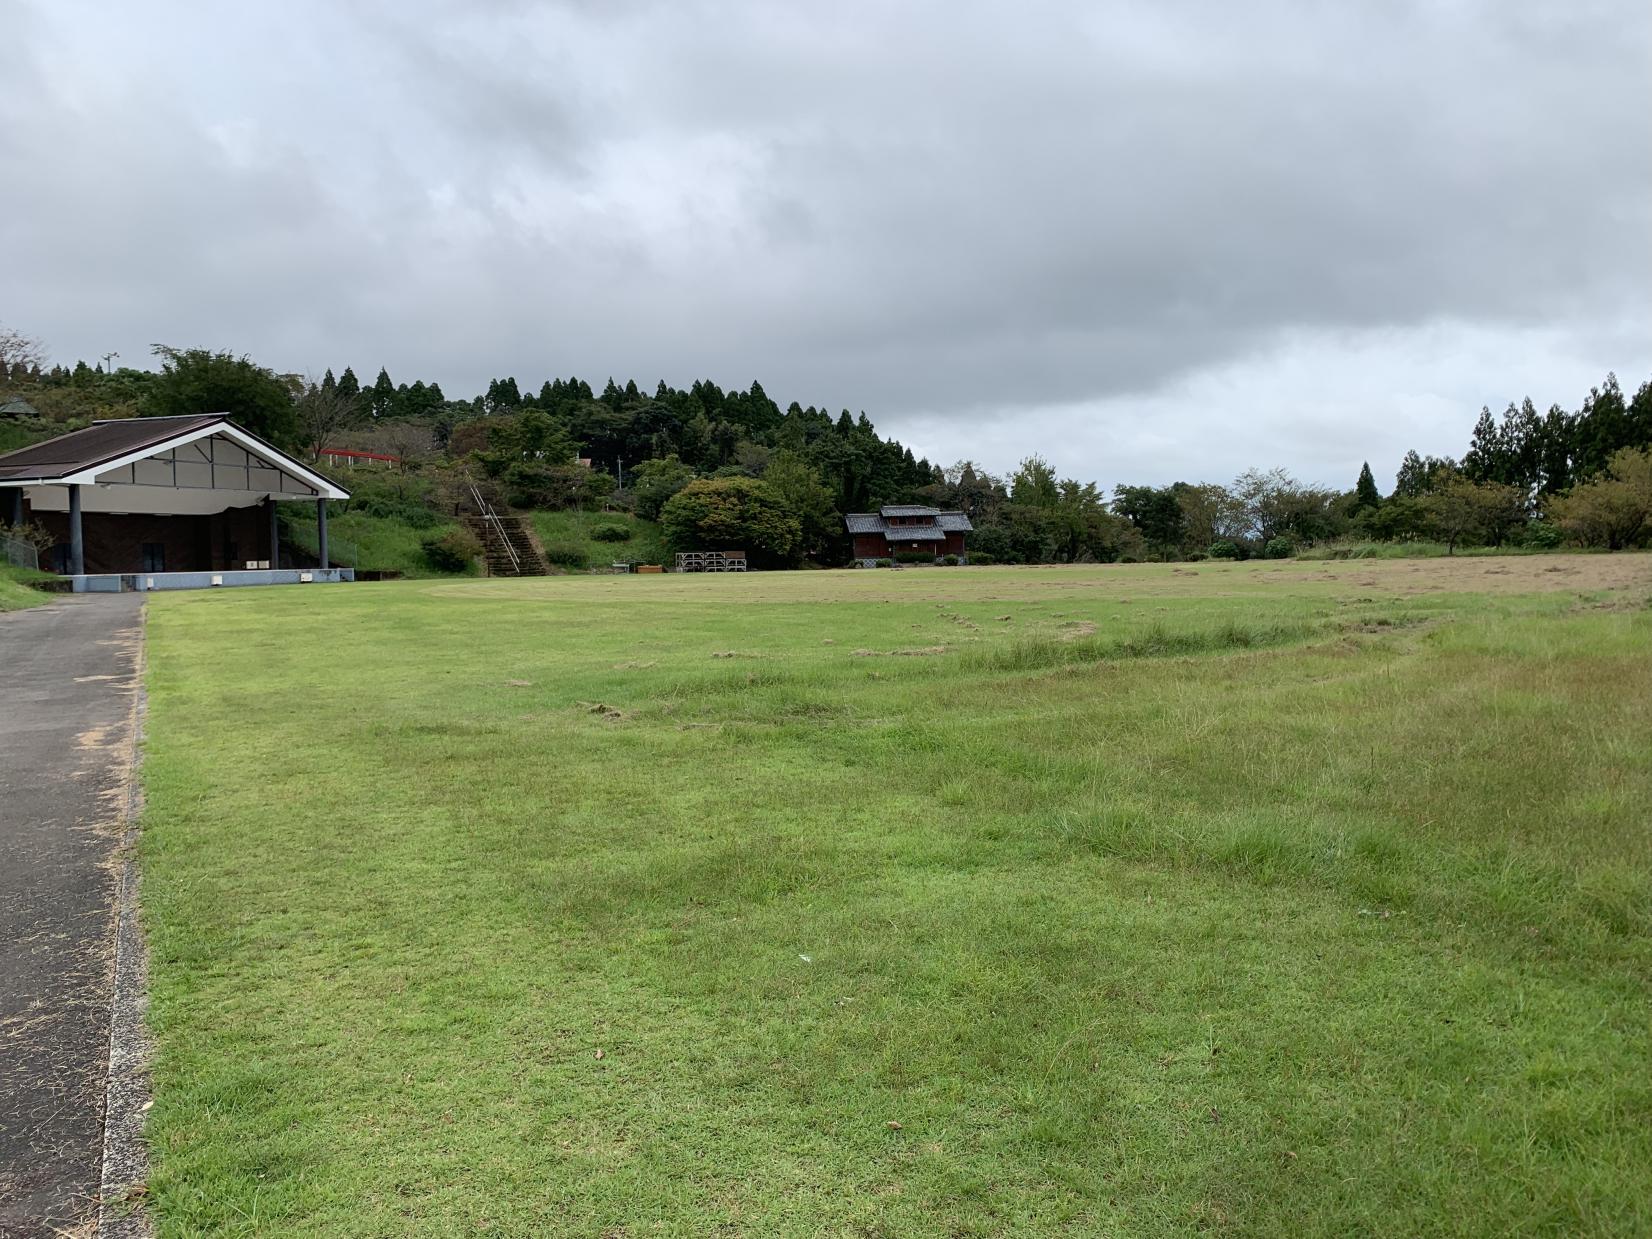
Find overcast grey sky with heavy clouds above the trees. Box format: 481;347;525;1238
0;0;1652;487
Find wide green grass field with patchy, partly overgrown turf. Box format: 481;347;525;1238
142;555;1652;1237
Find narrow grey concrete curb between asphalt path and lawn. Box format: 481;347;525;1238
96;605;154;1239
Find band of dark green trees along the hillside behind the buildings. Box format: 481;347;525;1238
0;330;1652;565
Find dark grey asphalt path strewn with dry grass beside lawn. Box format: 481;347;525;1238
0;593;142;1239
